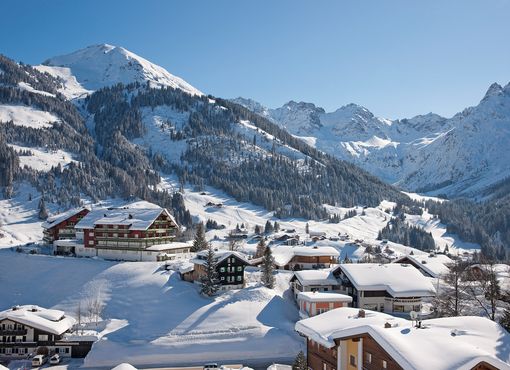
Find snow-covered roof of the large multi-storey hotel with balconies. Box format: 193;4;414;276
75;207;177;230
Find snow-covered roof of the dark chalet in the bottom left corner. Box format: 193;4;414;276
0;305;76;335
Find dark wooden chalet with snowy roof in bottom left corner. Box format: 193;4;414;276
0;306;97;360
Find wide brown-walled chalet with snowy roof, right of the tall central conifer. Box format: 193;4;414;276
271;245;340;270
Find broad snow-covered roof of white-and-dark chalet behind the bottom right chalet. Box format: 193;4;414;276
338;263;436;297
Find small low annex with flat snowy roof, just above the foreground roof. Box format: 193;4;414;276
297;291;352;319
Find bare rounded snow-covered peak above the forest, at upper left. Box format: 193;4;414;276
38;44;202;95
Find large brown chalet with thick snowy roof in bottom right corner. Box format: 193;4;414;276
295;307;510;370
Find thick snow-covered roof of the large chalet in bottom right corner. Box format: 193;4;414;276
295;307;510;370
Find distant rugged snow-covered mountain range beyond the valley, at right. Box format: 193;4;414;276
234;84;510;196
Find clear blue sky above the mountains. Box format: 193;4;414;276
0;0;510;118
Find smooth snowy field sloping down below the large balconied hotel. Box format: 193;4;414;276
0;250;303;368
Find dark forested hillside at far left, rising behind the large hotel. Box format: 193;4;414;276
0;53;191;225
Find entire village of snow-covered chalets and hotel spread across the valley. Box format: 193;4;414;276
0;202;510;370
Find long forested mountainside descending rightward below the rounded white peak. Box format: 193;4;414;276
86;84;406;219
